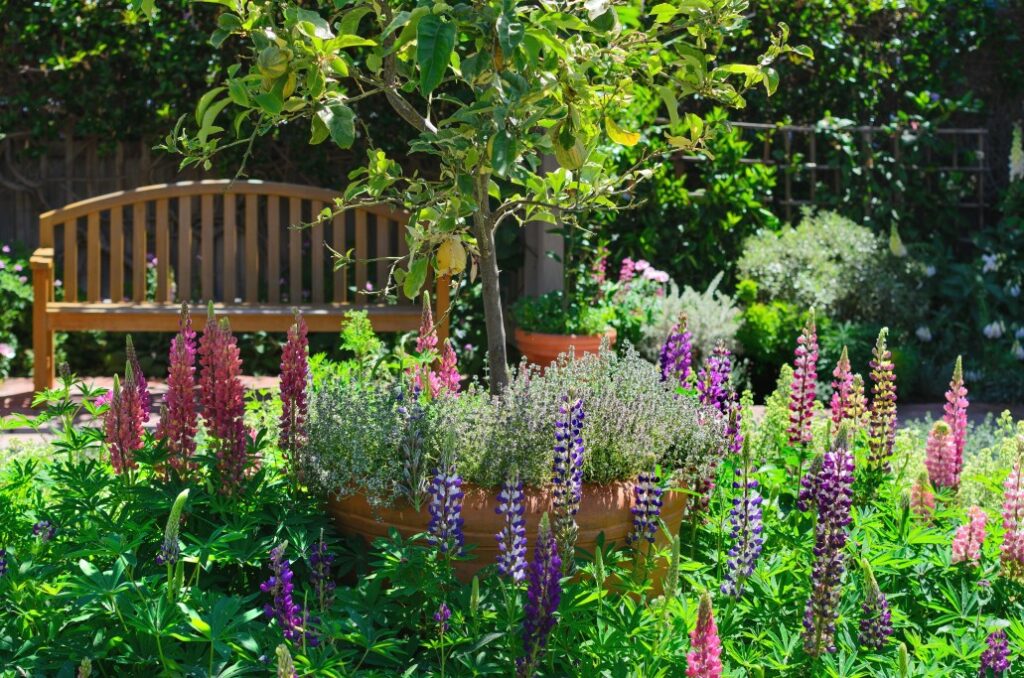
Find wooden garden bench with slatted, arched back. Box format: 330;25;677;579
32;180;449;390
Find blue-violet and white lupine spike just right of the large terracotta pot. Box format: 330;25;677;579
722;444;765;598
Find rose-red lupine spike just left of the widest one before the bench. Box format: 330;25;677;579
157;304;199;477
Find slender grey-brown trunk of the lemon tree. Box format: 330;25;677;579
473;176;509;395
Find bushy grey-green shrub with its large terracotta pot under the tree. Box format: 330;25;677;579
300;350;724;577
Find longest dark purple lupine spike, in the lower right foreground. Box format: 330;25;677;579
801;427;853;656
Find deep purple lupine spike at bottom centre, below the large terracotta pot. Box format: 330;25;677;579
516;515;562;678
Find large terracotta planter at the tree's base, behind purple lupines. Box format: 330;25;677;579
328;482;687;581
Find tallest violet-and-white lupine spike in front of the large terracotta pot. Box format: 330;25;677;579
551;395;585;574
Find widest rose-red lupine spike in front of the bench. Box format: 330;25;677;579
199;306;249;495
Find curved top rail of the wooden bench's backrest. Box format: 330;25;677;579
39;179;408;247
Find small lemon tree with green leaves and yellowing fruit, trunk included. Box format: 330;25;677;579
155;0;809;391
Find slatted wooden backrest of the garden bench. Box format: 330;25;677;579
39;180;409;304
